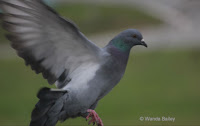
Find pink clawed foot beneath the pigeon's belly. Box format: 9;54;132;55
86;109;103;126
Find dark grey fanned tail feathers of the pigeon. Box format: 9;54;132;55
30;88;68;126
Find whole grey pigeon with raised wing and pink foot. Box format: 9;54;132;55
0;0;147;126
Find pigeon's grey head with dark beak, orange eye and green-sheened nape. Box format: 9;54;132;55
110;29;147;51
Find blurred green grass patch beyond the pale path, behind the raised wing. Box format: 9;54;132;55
0;3;161;43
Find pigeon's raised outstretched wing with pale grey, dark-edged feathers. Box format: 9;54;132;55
0;0;101;87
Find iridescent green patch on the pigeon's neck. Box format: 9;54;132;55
111;39;131;52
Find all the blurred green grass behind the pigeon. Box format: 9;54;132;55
0;3;200;126
